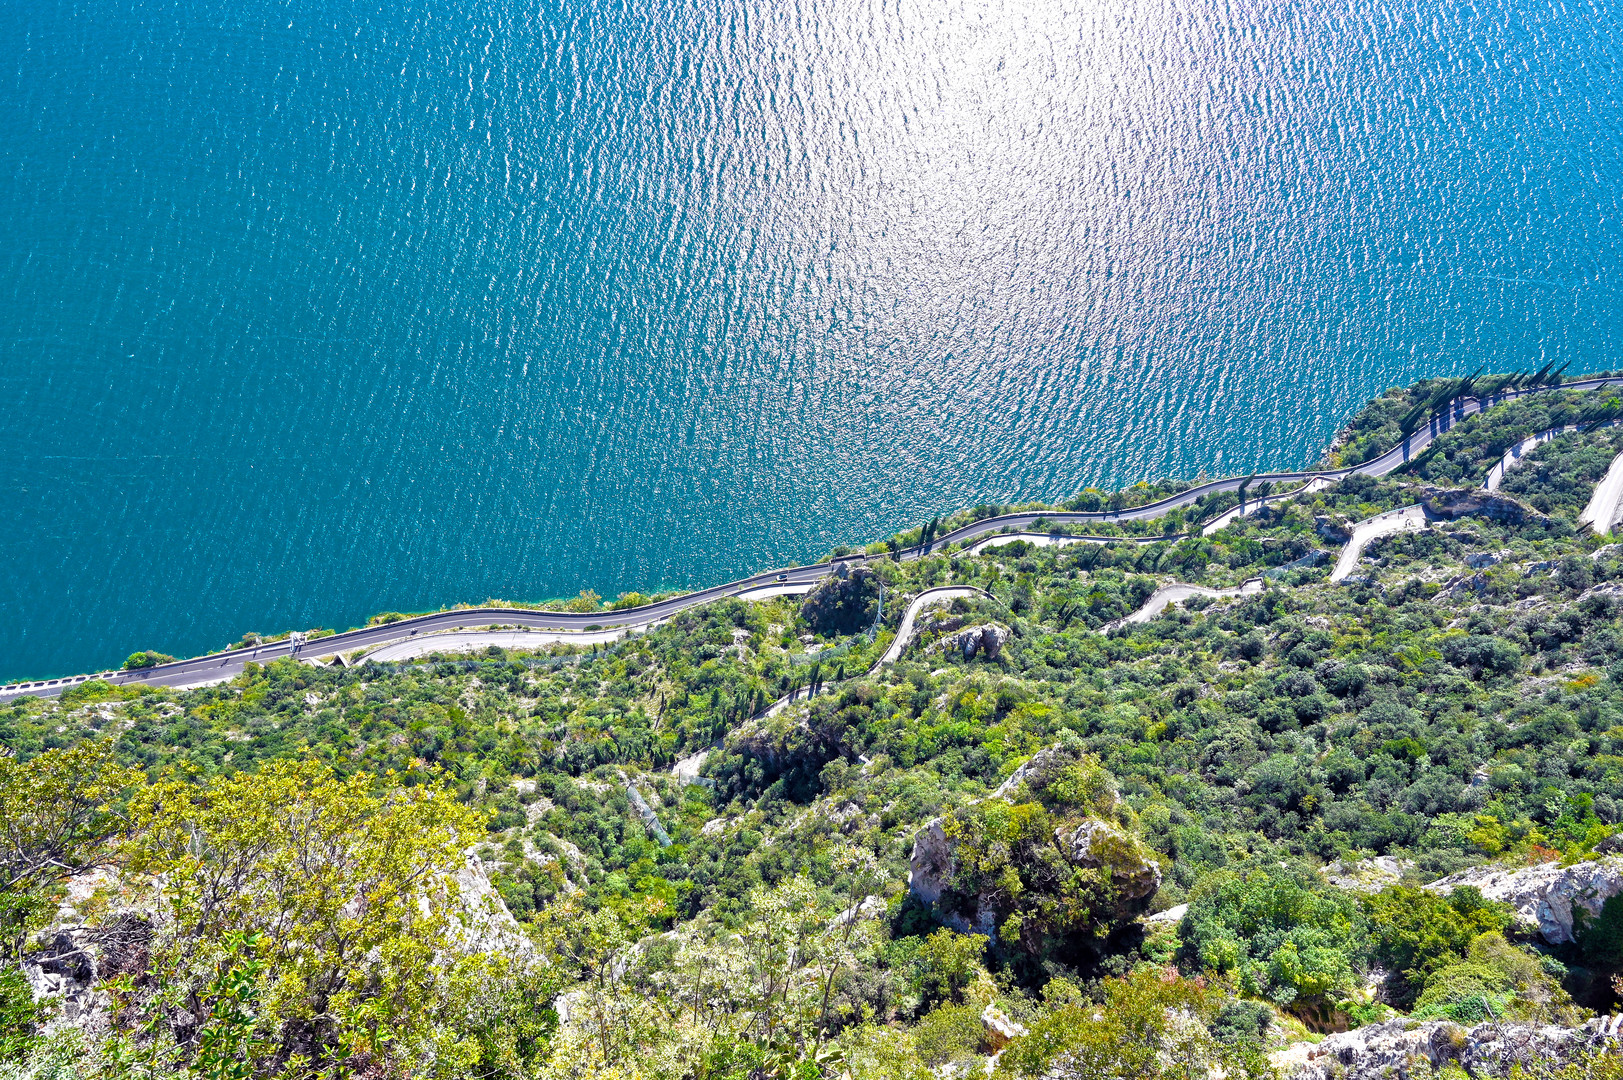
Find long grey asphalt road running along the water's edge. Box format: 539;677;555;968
0;377;1623;700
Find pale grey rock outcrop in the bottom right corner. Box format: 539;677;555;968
1274;1017;1623;1080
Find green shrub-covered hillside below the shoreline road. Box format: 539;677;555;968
0;376;1623;1080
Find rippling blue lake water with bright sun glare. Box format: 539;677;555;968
0;0;1623;676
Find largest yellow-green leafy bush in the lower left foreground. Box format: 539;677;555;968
122;762;499;1072
